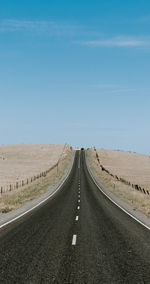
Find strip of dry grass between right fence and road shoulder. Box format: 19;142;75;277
87;148;150;217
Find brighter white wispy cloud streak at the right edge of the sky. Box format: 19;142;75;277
80;36;150;47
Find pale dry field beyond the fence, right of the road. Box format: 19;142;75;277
97;149;150;189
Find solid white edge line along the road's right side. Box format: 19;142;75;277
87;158;150;230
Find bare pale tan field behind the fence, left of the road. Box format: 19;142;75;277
0;144;69;191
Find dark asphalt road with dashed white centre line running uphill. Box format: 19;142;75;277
0;151;150;284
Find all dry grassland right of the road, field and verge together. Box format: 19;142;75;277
87;149;150;217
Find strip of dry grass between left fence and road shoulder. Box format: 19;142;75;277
0;150;73;213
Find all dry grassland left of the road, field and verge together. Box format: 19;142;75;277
0;145;72;213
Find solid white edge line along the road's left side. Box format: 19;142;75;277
0;154;73;229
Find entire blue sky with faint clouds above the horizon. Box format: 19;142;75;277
0;0;150;153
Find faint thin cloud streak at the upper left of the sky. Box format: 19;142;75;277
0;19;81;36
